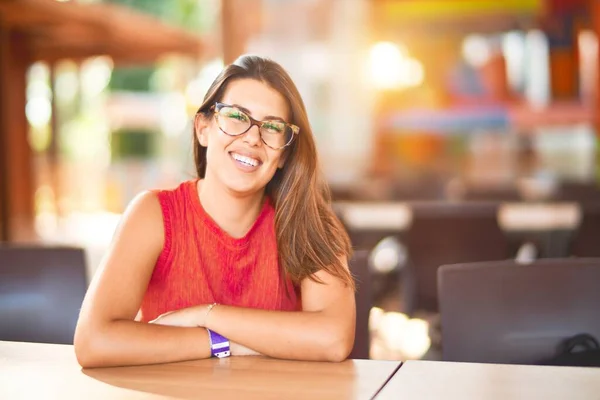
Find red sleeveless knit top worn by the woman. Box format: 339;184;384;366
141;181;299;322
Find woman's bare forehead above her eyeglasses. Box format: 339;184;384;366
221;79;289;121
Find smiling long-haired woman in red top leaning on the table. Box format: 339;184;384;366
75;56;355;367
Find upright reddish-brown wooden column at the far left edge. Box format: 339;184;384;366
0;22;35;242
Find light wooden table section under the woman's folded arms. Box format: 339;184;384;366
0;342;400;400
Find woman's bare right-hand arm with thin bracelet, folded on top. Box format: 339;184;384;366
154;264;356;361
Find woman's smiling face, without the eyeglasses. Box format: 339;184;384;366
196;79;289;195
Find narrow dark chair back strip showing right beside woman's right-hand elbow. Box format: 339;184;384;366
349;250;372;359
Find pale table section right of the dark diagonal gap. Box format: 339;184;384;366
377;361;600;400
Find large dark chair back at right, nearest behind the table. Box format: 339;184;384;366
438;259;600;364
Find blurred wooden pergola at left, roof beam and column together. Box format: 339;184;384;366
0;0;204;241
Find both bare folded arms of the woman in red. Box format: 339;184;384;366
75;193;355;367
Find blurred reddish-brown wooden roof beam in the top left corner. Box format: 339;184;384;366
0;0;205;64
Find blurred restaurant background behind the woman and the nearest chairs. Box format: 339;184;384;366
0;0;600;359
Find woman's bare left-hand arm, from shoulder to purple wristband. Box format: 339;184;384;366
75;193;210;367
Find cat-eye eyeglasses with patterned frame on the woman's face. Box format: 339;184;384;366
213;103;300;150
